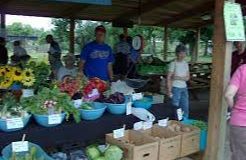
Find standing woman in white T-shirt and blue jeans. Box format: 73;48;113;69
167;45;190;118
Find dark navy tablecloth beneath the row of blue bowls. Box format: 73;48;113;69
0;104;175;150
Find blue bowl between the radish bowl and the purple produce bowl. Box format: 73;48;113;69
80;102;106;120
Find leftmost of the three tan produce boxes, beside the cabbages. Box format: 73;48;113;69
106;130;159;160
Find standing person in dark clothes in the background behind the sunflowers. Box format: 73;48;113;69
46;35;62;78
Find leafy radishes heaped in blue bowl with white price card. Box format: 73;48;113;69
21;88;80;127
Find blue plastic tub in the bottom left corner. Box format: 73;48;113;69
0;142;53;160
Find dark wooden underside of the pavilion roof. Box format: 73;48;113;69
0;0;246;28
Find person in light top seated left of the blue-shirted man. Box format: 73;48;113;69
57;55;78;81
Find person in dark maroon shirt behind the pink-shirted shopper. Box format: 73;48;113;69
231;41;246;76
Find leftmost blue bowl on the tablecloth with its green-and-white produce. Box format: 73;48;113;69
0;93;31;132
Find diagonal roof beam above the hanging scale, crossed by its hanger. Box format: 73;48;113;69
115;0;173;19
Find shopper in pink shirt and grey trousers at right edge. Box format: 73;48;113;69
225;64;246;160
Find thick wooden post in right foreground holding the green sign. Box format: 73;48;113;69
204;0;232;160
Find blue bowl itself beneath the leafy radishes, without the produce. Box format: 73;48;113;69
33;113;66;127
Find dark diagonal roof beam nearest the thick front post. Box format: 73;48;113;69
157;1;214;25
